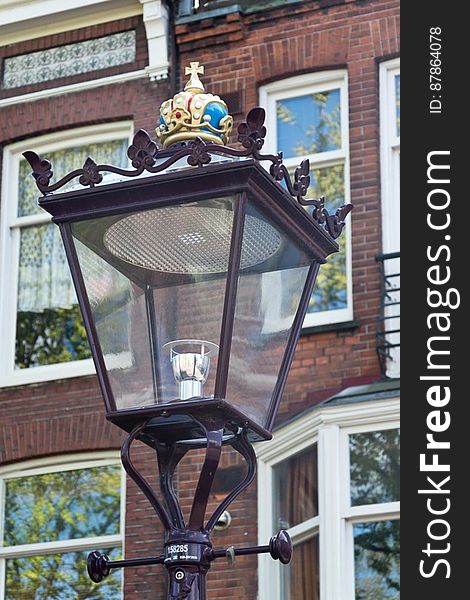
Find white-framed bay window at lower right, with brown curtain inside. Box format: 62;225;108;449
258;399;400;600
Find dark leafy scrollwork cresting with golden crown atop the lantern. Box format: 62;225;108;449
23;62;353;239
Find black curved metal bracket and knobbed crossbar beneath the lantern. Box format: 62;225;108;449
87;420;292;600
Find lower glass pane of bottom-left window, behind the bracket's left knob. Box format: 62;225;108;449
5;548;122;600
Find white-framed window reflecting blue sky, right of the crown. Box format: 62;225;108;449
260;71;353;327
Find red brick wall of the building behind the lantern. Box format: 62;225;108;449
0;0;399;600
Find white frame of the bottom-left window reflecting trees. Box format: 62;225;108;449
0;451;126;598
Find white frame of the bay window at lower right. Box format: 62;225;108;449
255;398;400;600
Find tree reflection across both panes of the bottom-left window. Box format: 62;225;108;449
4;466;121;600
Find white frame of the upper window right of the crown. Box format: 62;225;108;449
259;69;353;328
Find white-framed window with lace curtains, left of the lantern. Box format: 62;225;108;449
0;123;131;385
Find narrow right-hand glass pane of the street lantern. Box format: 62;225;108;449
226;202;313;427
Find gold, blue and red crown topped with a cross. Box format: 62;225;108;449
156;62;233;148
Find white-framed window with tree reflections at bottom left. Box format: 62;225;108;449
0;453;125;600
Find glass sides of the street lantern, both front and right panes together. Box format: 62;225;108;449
72;194;314;427
